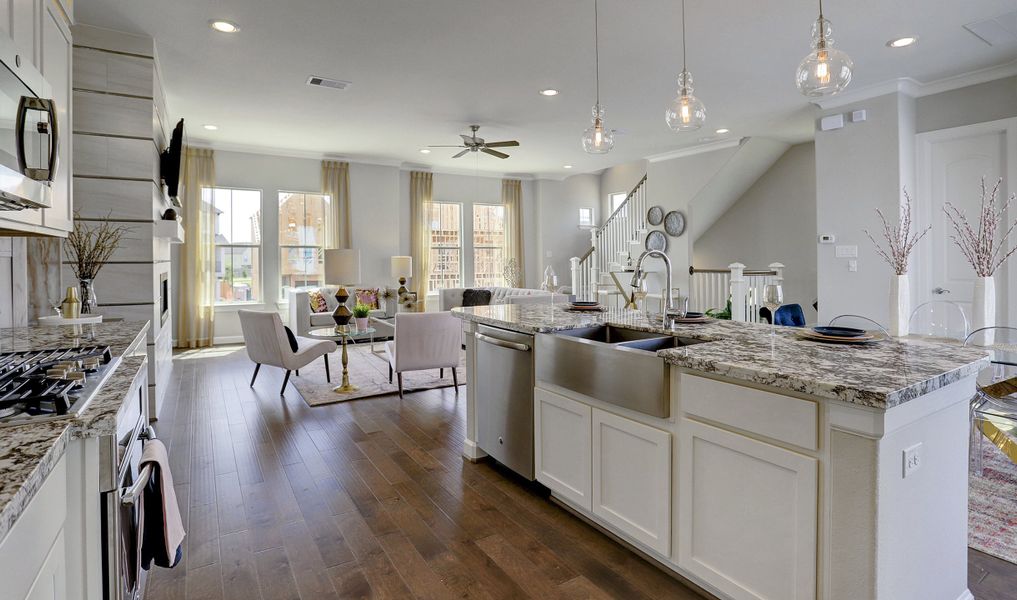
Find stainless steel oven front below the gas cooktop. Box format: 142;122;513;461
99;368;156;600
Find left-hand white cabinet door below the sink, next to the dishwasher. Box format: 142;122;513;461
533;387;593;511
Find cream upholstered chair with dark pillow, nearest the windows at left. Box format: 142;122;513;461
237;310;338;396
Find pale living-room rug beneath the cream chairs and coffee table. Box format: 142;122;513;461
290;344;466;406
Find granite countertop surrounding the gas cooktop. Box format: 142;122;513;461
0;321;148;540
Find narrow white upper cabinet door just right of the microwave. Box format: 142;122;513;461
42;1;74;232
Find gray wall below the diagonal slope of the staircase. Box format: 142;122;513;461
693;142;817;321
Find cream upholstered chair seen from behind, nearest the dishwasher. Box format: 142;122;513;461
384;312;463;398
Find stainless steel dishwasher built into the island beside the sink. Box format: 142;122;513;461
474;325;533;481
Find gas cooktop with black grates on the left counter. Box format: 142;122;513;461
0;346;118;426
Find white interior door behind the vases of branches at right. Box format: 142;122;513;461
912;119;1017;324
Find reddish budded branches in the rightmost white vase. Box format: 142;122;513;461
943;177;1017;277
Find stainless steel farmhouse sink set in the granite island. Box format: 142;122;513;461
534;325;703;418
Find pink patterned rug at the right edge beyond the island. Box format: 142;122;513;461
967;439;1017;563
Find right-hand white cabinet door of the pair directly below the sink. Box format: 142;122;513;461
593;409;671;556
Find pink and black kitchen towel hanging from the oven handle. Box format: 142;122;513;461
139;439;186;571
